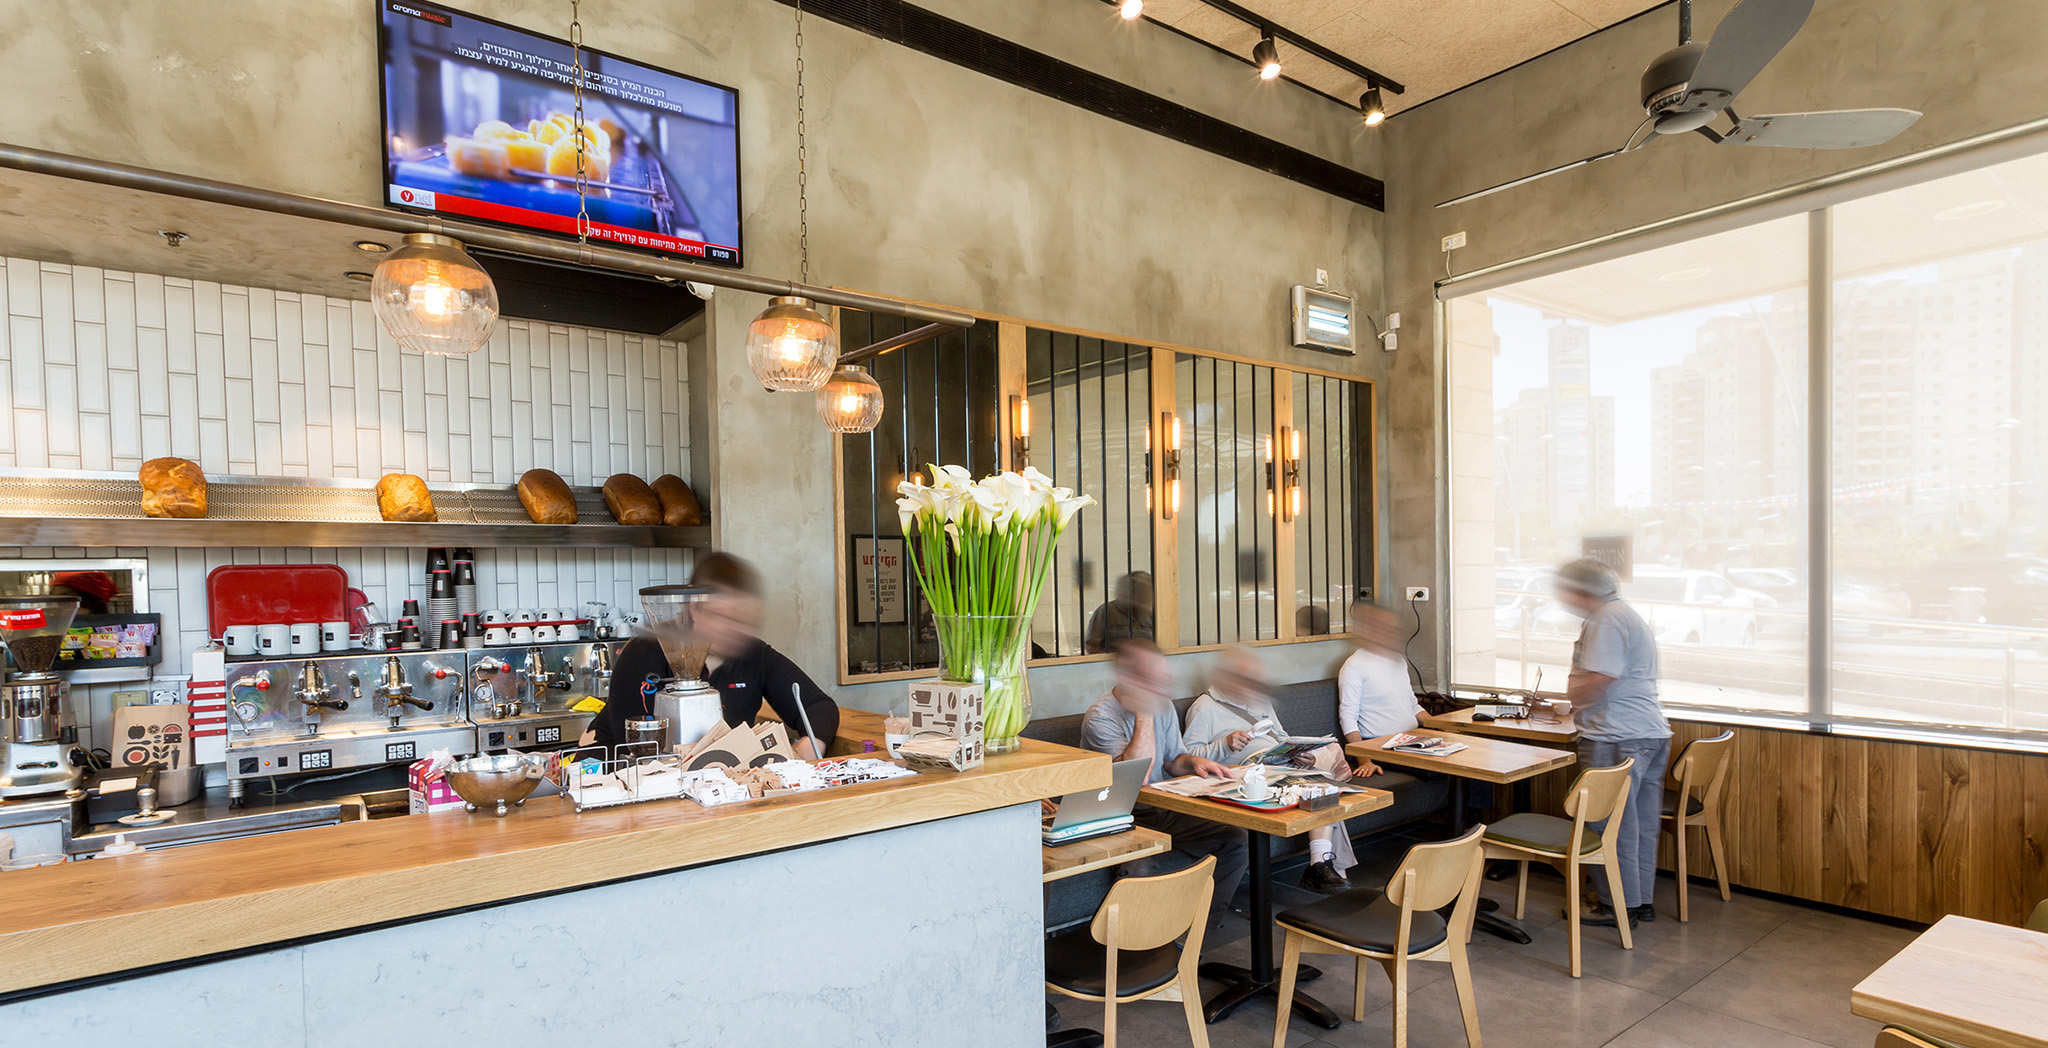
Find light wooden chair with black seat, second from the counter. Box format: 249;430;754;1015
1274;825;1487;1048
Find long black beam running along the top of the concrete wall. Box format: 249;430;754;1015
778;0;1386;211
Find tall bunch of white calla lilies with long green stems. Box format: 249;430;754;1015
897;467;1096;753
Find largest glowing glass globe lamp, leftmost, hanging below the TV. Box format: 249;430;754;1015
371;233;498;356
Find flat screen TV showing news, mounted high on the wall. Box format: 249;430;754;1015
377;0;741;268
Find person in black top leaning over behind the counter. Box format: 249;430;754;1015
590;553;840;761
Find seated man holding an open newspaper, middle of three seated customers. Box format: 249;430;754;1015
1182;647;1380;892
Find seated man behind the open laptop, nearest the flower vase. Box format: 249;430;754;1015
1081;639;1249;931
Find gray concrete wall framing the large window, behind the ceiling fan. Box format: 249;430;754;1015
1382;0;2048;683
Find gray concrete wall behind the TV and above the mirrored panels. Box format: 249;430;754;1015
0;0;1384;712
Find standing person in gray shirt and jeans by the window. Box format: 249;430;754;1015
1556;557;1683;927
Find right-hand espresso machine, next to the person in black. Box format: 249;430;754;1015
469;641;625;753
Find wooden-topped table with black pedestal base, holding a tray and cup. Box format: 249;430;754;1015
1139;786;1395;1030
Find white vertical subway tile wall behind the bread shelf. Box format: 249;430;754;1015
0;258;690;745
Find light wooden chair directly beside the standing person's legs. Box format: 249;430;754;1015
1485;757;1636;978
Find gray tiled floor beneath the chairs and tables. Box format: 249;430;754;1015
1057;843;1913;1048
